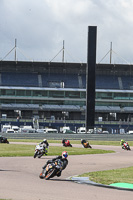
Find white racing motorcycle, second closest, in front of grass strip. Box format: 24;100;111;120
34;144;48;158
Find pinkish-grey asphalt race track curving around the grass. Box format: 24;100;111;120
0;144;133;200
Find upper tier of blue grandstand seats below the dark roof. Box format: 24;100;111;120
0;72;133;89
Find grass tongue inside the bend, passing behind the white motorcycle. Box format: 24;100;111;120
0;144;114;157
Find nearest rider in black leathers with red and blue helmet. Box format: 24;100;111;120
43;151;68;177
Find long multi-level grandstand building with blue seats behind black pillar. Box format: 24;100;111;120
0;61;133;126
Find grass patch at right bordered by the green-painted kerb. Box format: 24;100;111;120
79;167;133;185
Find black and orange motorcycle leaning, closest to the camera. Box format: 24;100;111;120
39;159;63;180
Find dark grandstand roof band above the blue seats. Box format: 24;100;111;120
0;61;133;75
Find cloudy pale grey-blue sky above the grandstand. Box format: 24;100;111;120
0;0;133;64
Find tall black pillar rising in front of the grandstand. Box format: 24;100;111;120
86;26;97;131
